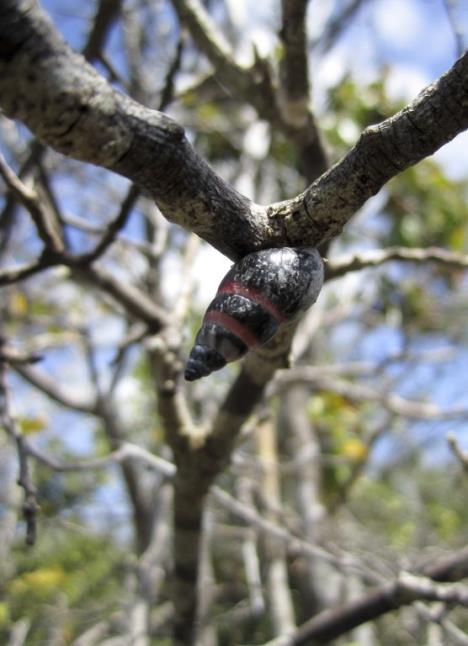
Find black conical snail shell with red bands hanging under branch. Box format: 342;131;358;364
185;247;323;381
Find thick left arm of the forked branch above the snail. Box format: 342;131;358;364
0;0;270;257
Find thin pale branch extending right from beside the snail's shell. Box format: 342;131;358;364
325;247;468;280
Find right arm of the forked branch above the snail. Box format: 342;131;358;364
268;52;468;244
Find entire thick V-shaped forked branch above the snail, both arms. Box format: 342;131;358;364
0;0;468;258
